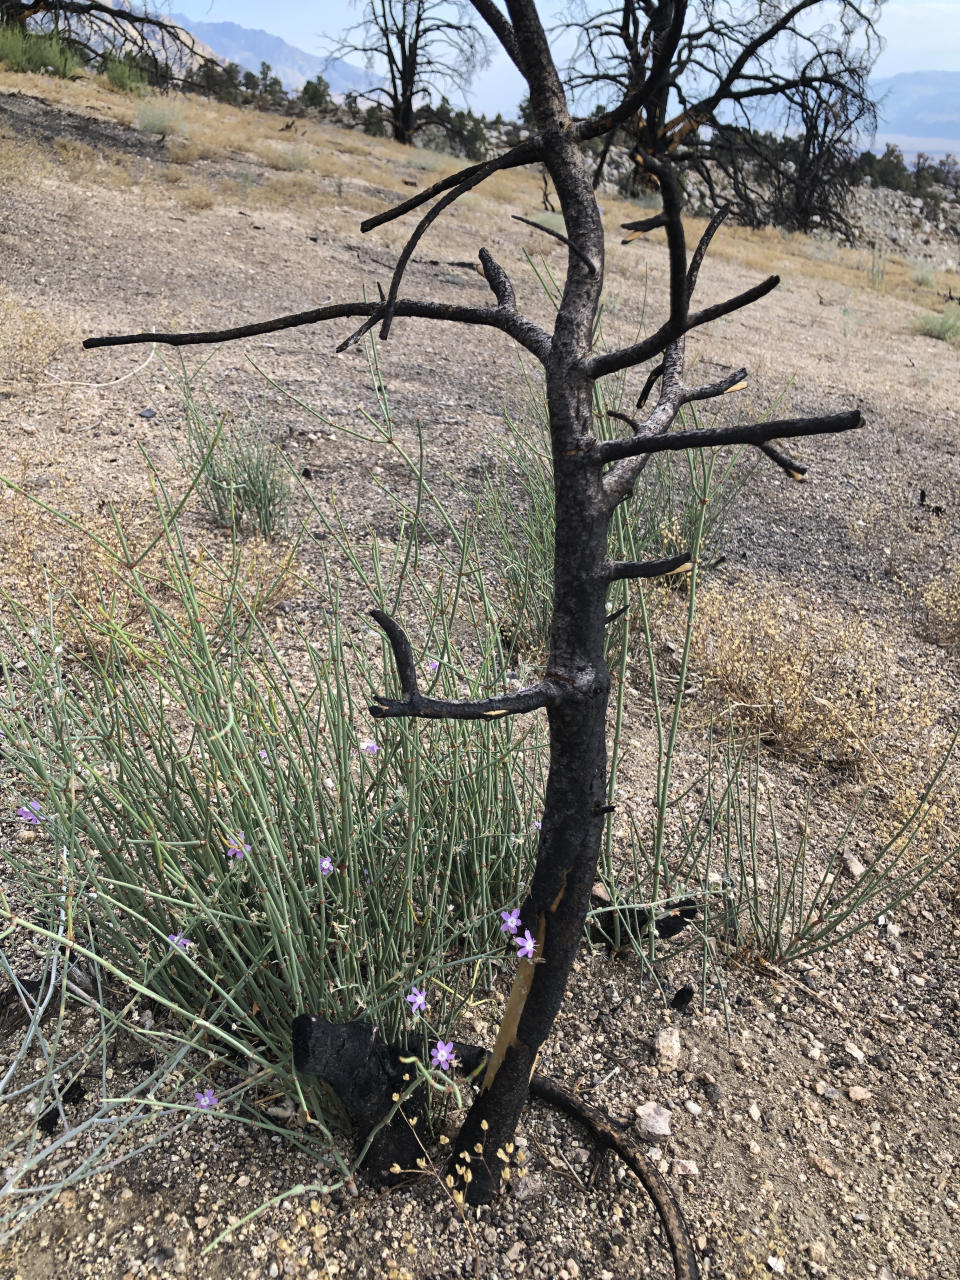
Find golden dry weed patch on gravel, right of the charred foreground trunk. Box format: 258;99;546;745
694;579;942;791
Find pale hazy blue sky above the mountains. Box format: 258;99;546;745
169;0;960;115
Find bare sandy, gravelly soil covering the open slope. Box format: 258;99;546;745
0;76;960;1280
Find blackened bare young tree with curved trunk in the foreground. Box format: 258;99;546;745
84;0;861;1280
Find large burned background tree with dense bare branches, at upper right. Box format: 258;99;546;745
566;0;881;230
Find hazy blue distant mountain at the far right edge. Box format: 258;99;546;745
870;72;960;155
